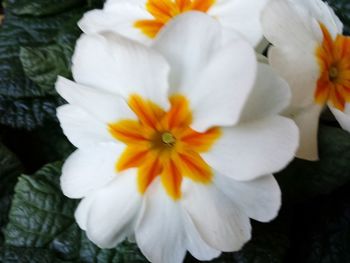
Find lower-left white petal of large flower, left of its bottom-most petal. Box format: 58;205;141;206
87;172;142;248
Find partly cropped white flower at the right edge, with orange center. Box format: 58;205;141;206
262;0;350;160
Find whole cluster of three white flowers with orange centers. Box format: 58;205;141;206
56;0;350;263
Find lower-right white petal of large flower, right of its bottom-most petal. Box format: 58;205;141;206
182;182;251;252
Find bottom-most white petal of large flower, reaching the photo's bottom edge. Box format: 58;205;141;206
135;178;186;263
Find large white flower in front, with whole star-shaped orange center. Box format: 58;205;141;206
57;12;298;263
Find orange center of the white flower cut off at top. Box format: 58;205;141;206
134;0;215;38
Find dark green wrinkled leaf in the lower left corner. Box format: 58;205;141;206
5;163;147;263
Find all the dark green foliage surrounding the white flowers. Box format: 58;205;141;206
0;0;350;263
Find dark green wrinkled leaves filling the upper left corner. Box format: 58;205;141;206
0;0;98;130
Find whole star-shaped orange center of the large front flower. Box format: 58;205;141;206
109;95;221;200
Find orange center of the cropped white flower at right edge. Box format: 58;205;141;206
315;24;350;111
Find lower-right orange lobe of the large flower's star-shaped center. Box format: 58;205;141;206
175;151;213;183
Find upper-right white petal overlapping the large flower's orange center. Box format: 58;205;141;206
189;39;257;131
